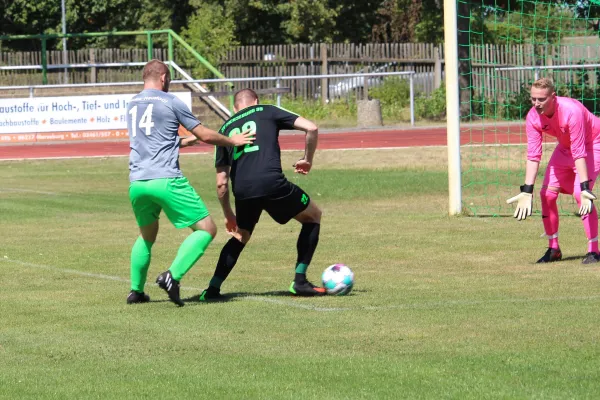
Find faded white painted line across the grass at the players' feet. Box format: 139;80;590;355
0;256;600;312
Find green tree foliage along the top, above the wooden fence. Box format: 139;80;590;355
0;0;600;49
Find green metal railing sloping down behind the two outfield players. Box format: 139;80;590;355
0;29;233;109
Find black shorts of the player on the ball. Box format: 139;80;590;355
235;181;310;232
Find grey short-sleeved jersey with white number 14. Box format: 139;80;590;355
126;89;200;182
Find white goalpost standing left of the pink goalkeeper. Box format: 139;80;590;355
444;0;462;215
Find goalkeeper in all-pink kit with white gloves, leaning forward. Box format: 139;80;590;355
507;78;600;264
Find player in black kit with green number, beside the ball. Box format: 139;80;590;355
200;89;326;301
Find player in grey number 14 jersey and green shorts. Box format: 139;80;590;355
127;60;254;306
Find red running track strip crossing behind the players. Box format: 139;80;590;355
0;125;524;160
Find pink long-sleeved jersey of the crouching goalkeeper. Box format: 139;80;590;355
525;97;600;162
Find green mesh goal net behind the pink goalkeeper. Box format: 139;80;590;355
457;0;600;216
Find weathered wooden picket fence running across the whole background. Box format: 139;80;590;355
0;42;600;98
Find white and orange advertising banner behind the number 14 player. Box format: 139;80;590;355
0;92;192;144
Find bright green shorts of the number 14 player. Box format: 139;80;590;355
129;177;210;229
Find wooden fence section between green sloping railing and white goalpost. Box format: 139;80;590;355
220;43;442;98
